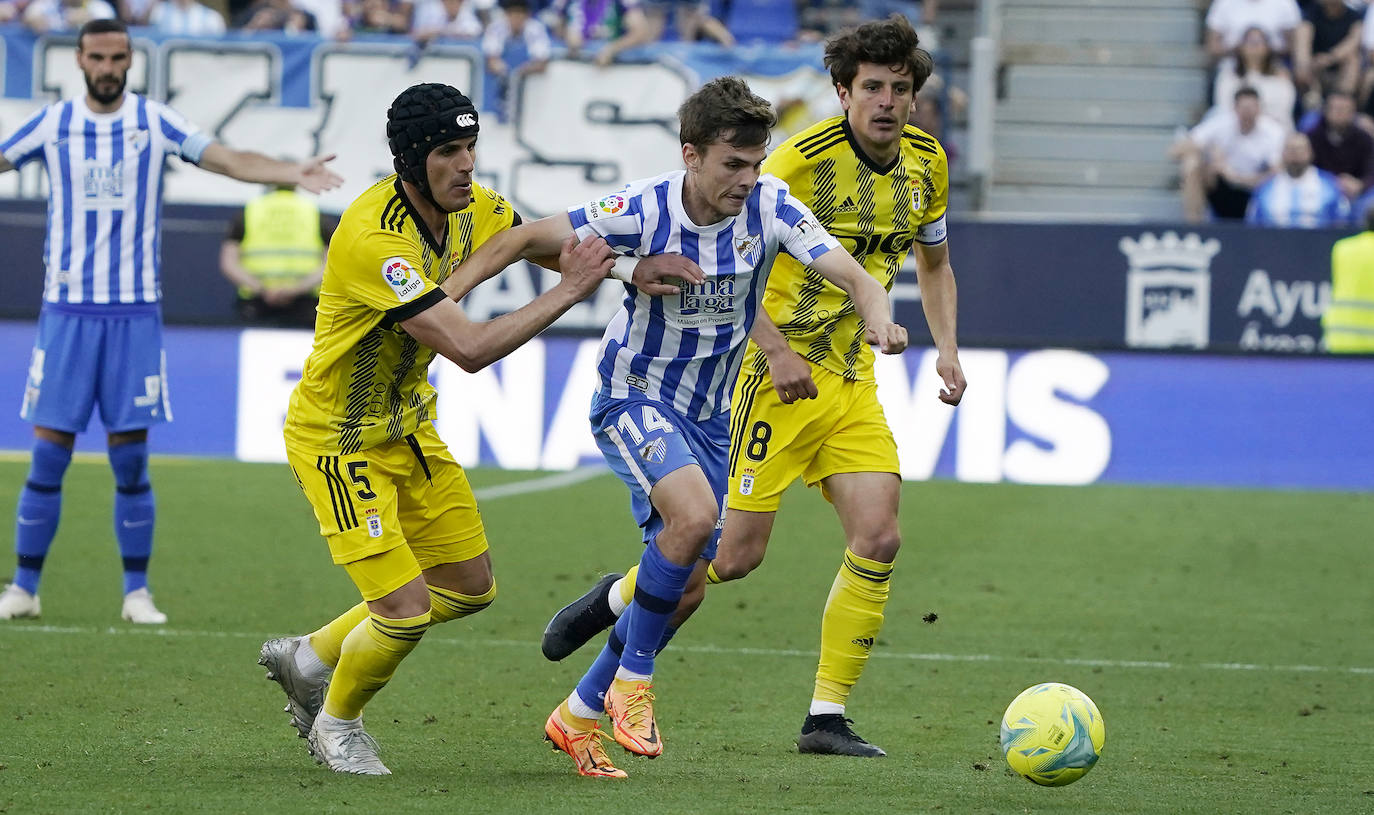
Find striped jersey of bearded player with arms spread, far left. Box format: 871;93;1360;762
0;93;213;305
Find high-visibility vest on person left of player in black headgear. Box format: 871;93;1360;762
239;190;324;297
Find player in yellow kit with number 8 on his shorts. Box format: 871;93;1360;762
543;16;966;756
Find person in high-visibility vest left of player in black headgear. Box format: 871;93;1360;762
220;184;335;328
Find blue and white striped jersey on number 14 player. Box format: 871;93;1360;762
569;170;840;421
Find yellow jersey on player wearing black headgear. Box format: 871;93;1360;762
284;175;519;455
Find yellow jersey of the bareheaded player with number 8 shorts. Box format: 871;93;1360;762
745;115;949;381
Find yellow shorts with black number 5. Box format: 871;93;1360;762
286;425;486;599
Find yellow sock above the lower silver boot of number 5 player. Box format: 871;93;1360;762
322;612;430;720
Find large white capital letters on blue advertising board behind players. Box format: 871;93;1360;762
235;330;1112;484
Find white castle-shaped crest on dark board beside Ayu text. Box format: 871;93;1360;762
1117;231;1221;348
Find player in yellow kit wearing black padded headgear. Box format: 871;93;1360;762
258;84;613;775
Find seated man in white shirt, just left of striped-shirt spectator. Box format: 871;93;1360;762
1172;88;1285;223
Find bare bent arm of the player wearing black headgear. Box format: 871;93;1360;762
401;235;614;372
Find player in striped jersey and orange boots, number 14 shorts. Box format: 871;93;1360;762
445;77;907;778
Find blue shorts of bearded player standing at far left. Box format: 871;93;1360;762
19;305;172;433
